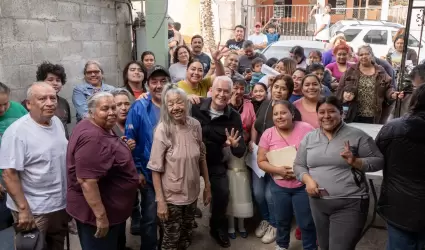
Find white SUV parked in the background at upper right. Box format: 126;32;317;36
331;20;425;61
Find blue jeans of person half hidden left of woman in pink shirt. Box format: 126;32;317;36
251;171;276;227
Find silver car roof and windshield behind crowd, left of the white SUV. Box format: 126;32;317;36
261;40;326;59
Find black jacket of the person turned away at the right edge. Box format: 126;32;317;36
376;112;425;232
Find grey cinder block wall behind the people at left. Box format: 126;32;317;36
0;0;131;125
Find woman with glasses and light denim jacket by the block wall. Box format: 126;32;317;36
72;60;114;122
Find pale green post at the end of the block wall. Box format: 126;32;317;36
145;0;168;67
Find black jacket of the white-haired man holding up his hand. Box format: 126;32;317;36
192;98;246;174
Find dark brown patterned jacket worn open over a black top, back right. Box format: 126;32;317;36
336;63;393;124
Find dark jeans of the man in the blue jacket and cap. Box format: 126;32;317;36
140;183;158;250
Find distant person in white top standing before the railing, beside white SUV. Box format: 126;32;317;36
310;4;332;42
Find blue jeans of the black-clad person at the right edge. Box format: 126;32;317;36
387;224;425;250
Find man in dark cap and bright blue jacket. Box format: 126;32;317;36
125;65;170;250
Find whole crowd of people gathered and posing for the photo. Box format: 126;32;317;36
0;20;425;250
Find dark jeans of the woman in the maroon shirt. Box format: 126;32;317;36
76;220;121;250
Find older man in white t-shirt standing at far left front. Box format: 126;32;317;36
0;82;69;250
